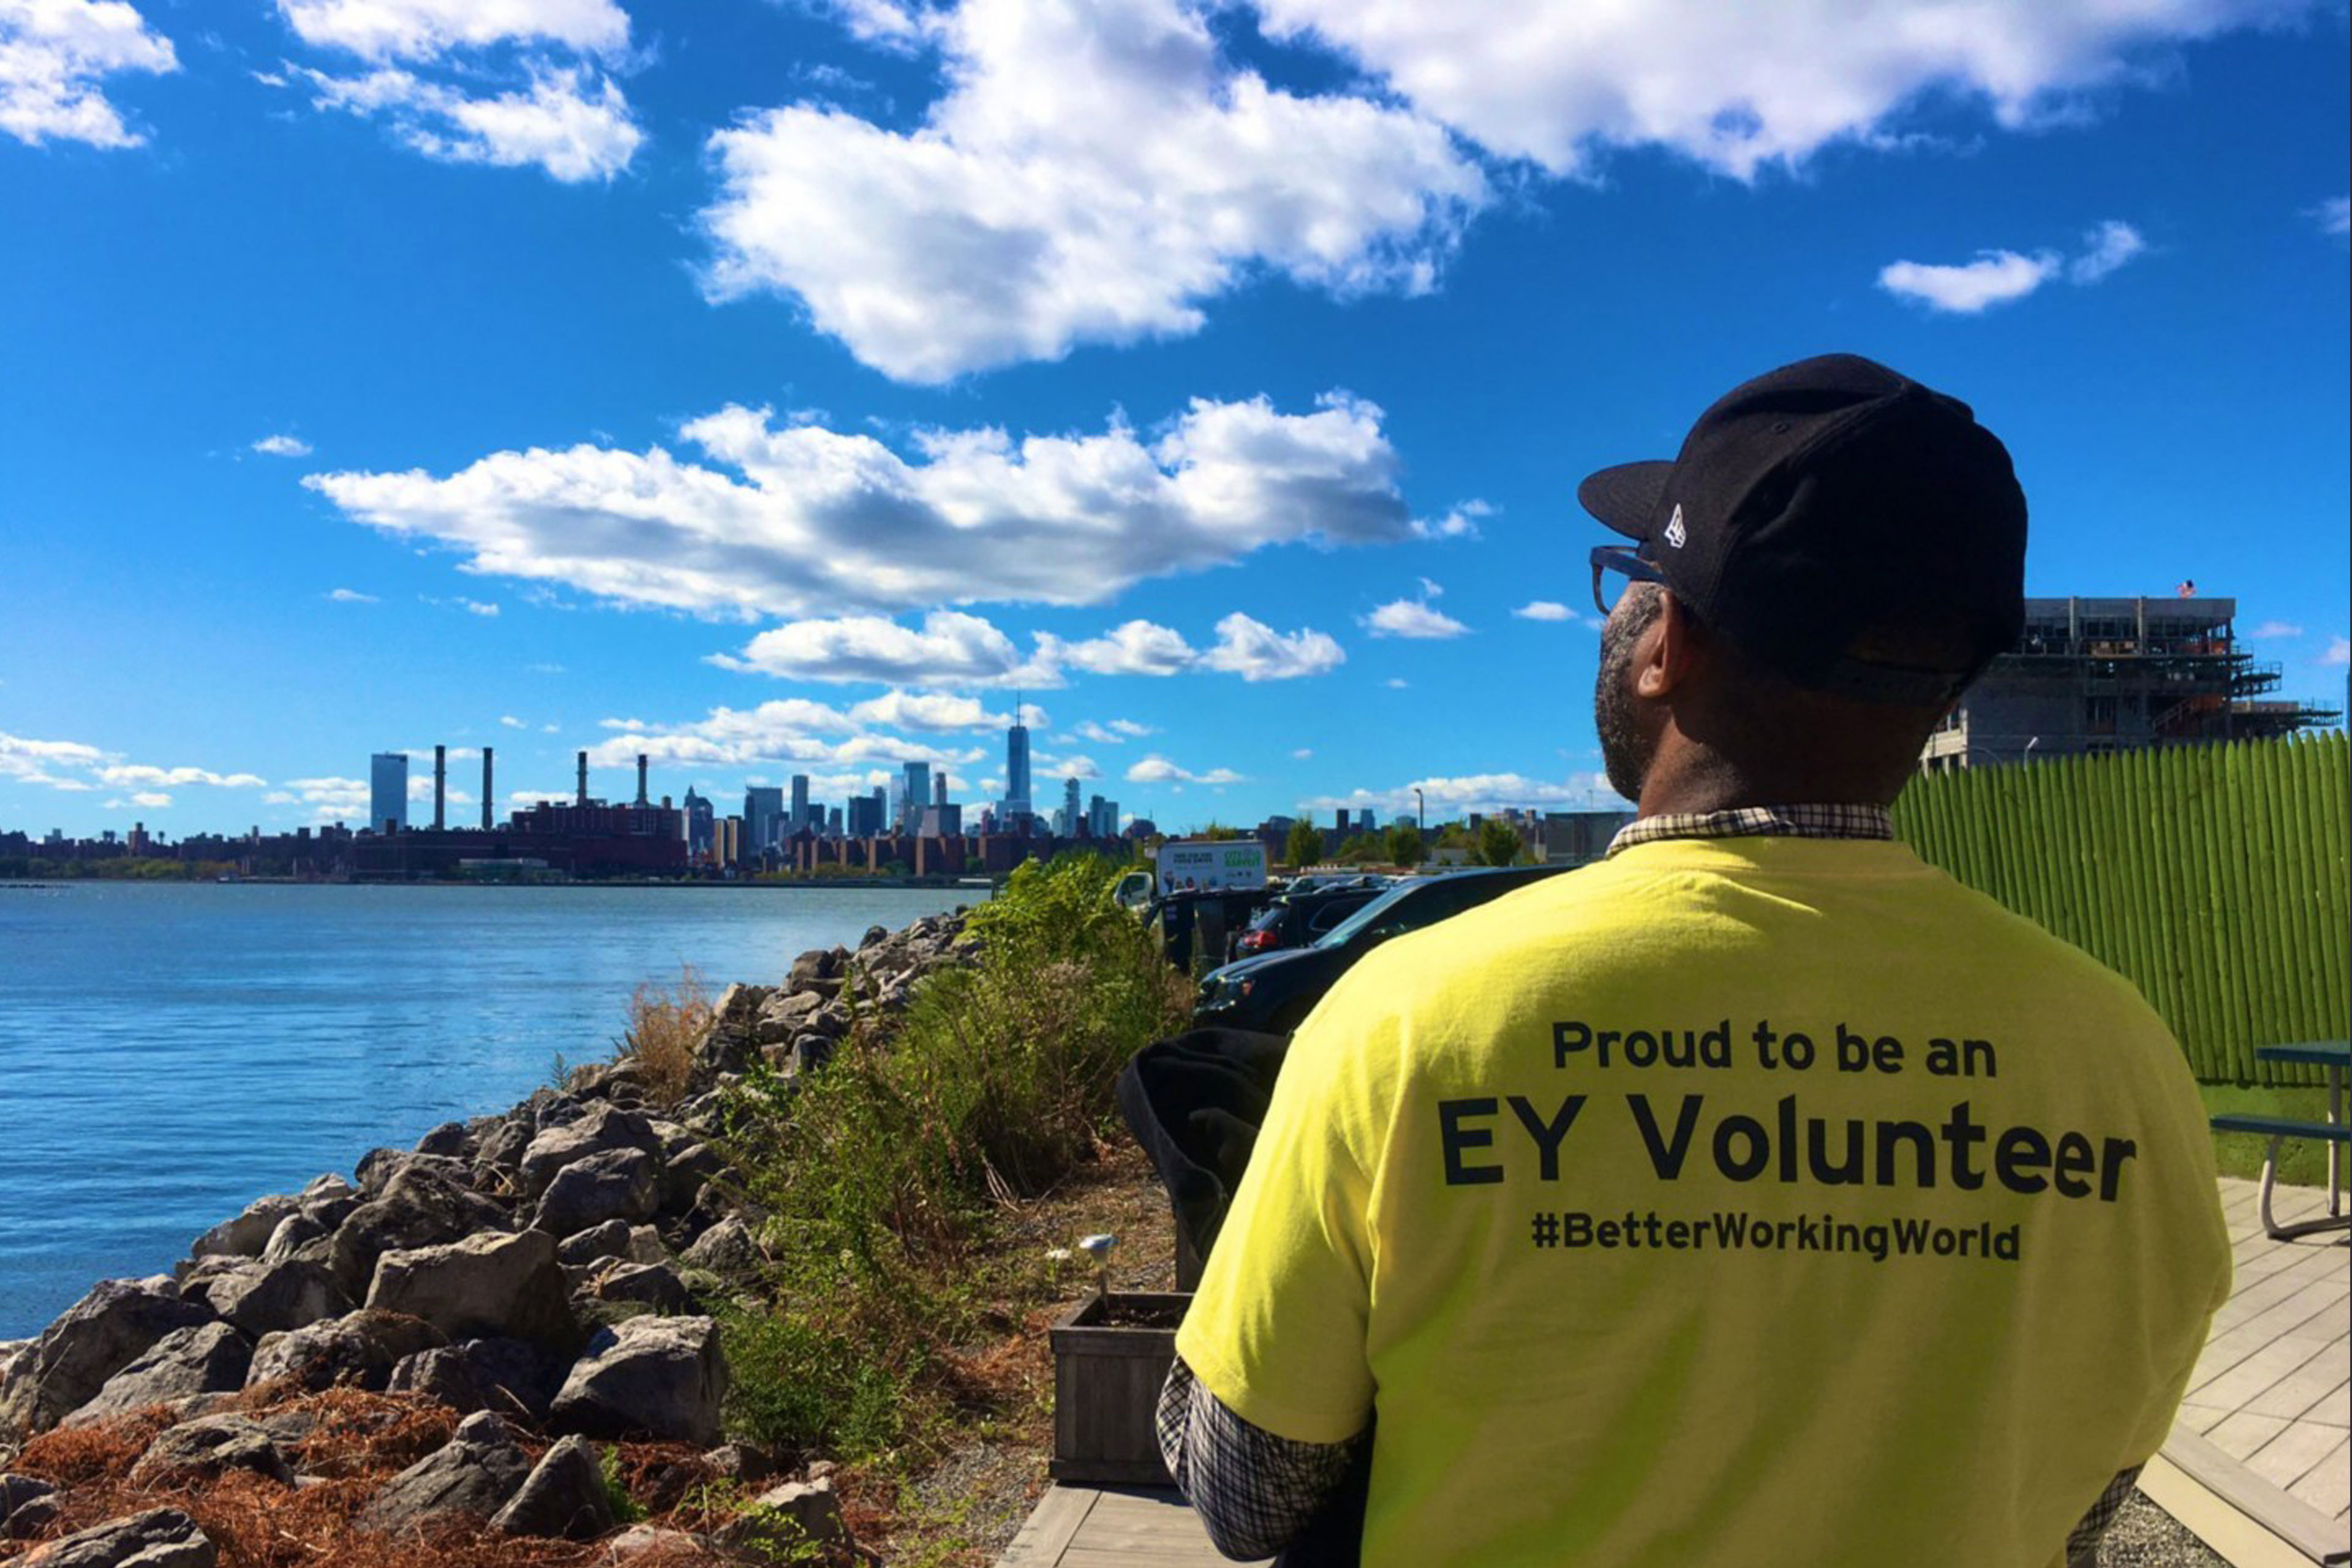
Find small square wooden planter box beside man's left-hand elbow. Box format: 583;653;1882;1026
1047;1291;1193;1486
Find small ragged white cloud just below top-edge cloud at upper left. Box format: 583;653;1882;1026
303;64;644;183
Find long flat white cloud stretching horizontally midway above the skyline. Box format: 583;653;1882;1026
317;393;1411;618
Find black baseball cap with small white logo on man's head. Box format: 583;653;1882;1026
1576;355;2025;705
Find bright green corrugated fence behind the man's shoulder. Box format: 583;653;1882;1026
1896;731;2352;1084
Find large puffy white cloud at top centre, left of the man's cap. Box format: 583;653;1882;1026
703;0;1487;381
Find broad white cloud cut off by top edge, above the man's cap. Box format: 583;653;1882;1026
1258;0;2305;179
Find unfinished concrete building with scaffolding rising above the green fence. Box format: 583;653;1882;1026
1919;597;2338;771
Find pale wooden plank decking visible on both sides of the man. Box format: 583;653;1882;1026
1000;1178;2352;1568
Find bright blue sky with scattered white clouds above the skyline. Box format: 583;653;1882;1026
0;0;2352;835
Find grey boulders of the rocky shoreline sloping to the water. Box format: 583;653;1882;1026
0;912;974;1568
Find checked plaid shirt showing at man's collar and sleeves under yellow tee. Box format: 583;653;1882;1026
1155;804;2140;1568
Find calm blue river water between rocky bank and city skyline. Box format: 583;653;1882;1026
0;881;986;1340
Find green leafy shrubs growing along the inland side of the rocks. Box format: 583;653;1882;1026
727;856;1190;1460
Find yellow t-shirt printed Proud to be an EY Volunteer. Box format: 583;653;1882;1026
1176;837;2230;1568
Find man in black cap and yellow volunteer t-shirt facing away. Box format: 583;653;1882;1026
1159;355;2230;1568
